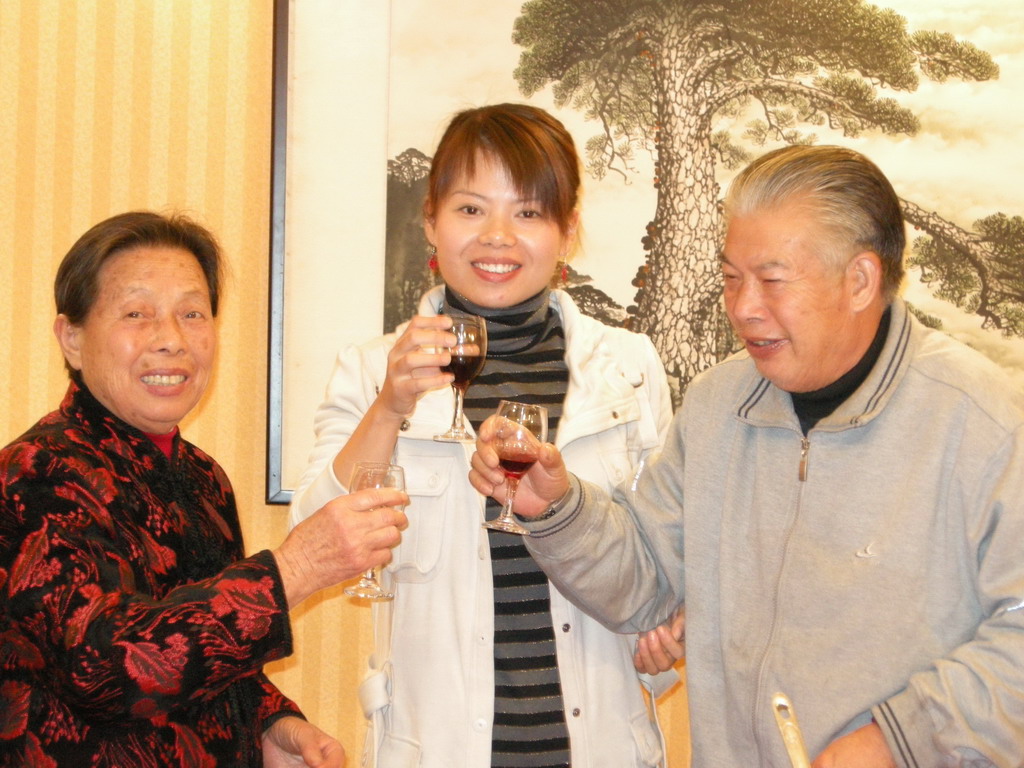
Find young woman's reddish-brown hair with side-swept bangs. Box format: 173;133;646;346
423;103;580;234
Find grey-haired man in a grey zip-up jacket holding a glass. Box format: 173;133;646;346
471;146;1024;768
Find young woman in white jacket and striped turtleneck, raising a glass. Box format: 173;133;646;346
292;104;681;768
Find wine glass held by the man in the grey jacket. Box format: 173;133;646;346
483;400;548;536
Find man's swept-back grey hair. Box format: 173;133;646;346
725;145;906;301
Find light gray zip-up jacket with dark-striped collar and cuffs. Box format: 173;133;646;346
527;301;1024;768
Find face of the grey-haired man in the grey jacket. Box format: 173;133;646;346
722;204;878;392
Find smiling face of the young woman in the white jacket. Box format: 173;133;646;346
424;156;575;309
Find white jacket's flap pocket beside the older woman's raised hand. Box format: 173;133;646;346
387;456;457;582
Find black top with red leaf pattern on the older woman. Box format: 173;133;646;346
0;384;299;768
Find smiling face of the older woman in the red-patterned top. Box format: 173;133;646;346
54;247;216;434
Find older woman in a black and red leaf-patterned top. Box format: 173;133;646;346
0;212;407;767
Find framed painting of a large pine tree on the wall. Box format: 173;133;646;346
268;0;1024;501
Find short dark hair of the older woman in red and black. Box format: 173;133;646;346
53;211;223;381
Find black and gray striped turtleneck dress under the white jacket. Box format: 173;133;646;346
445;291;569;768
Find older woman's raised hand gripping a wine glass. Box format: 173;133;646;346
273;488;409;608
